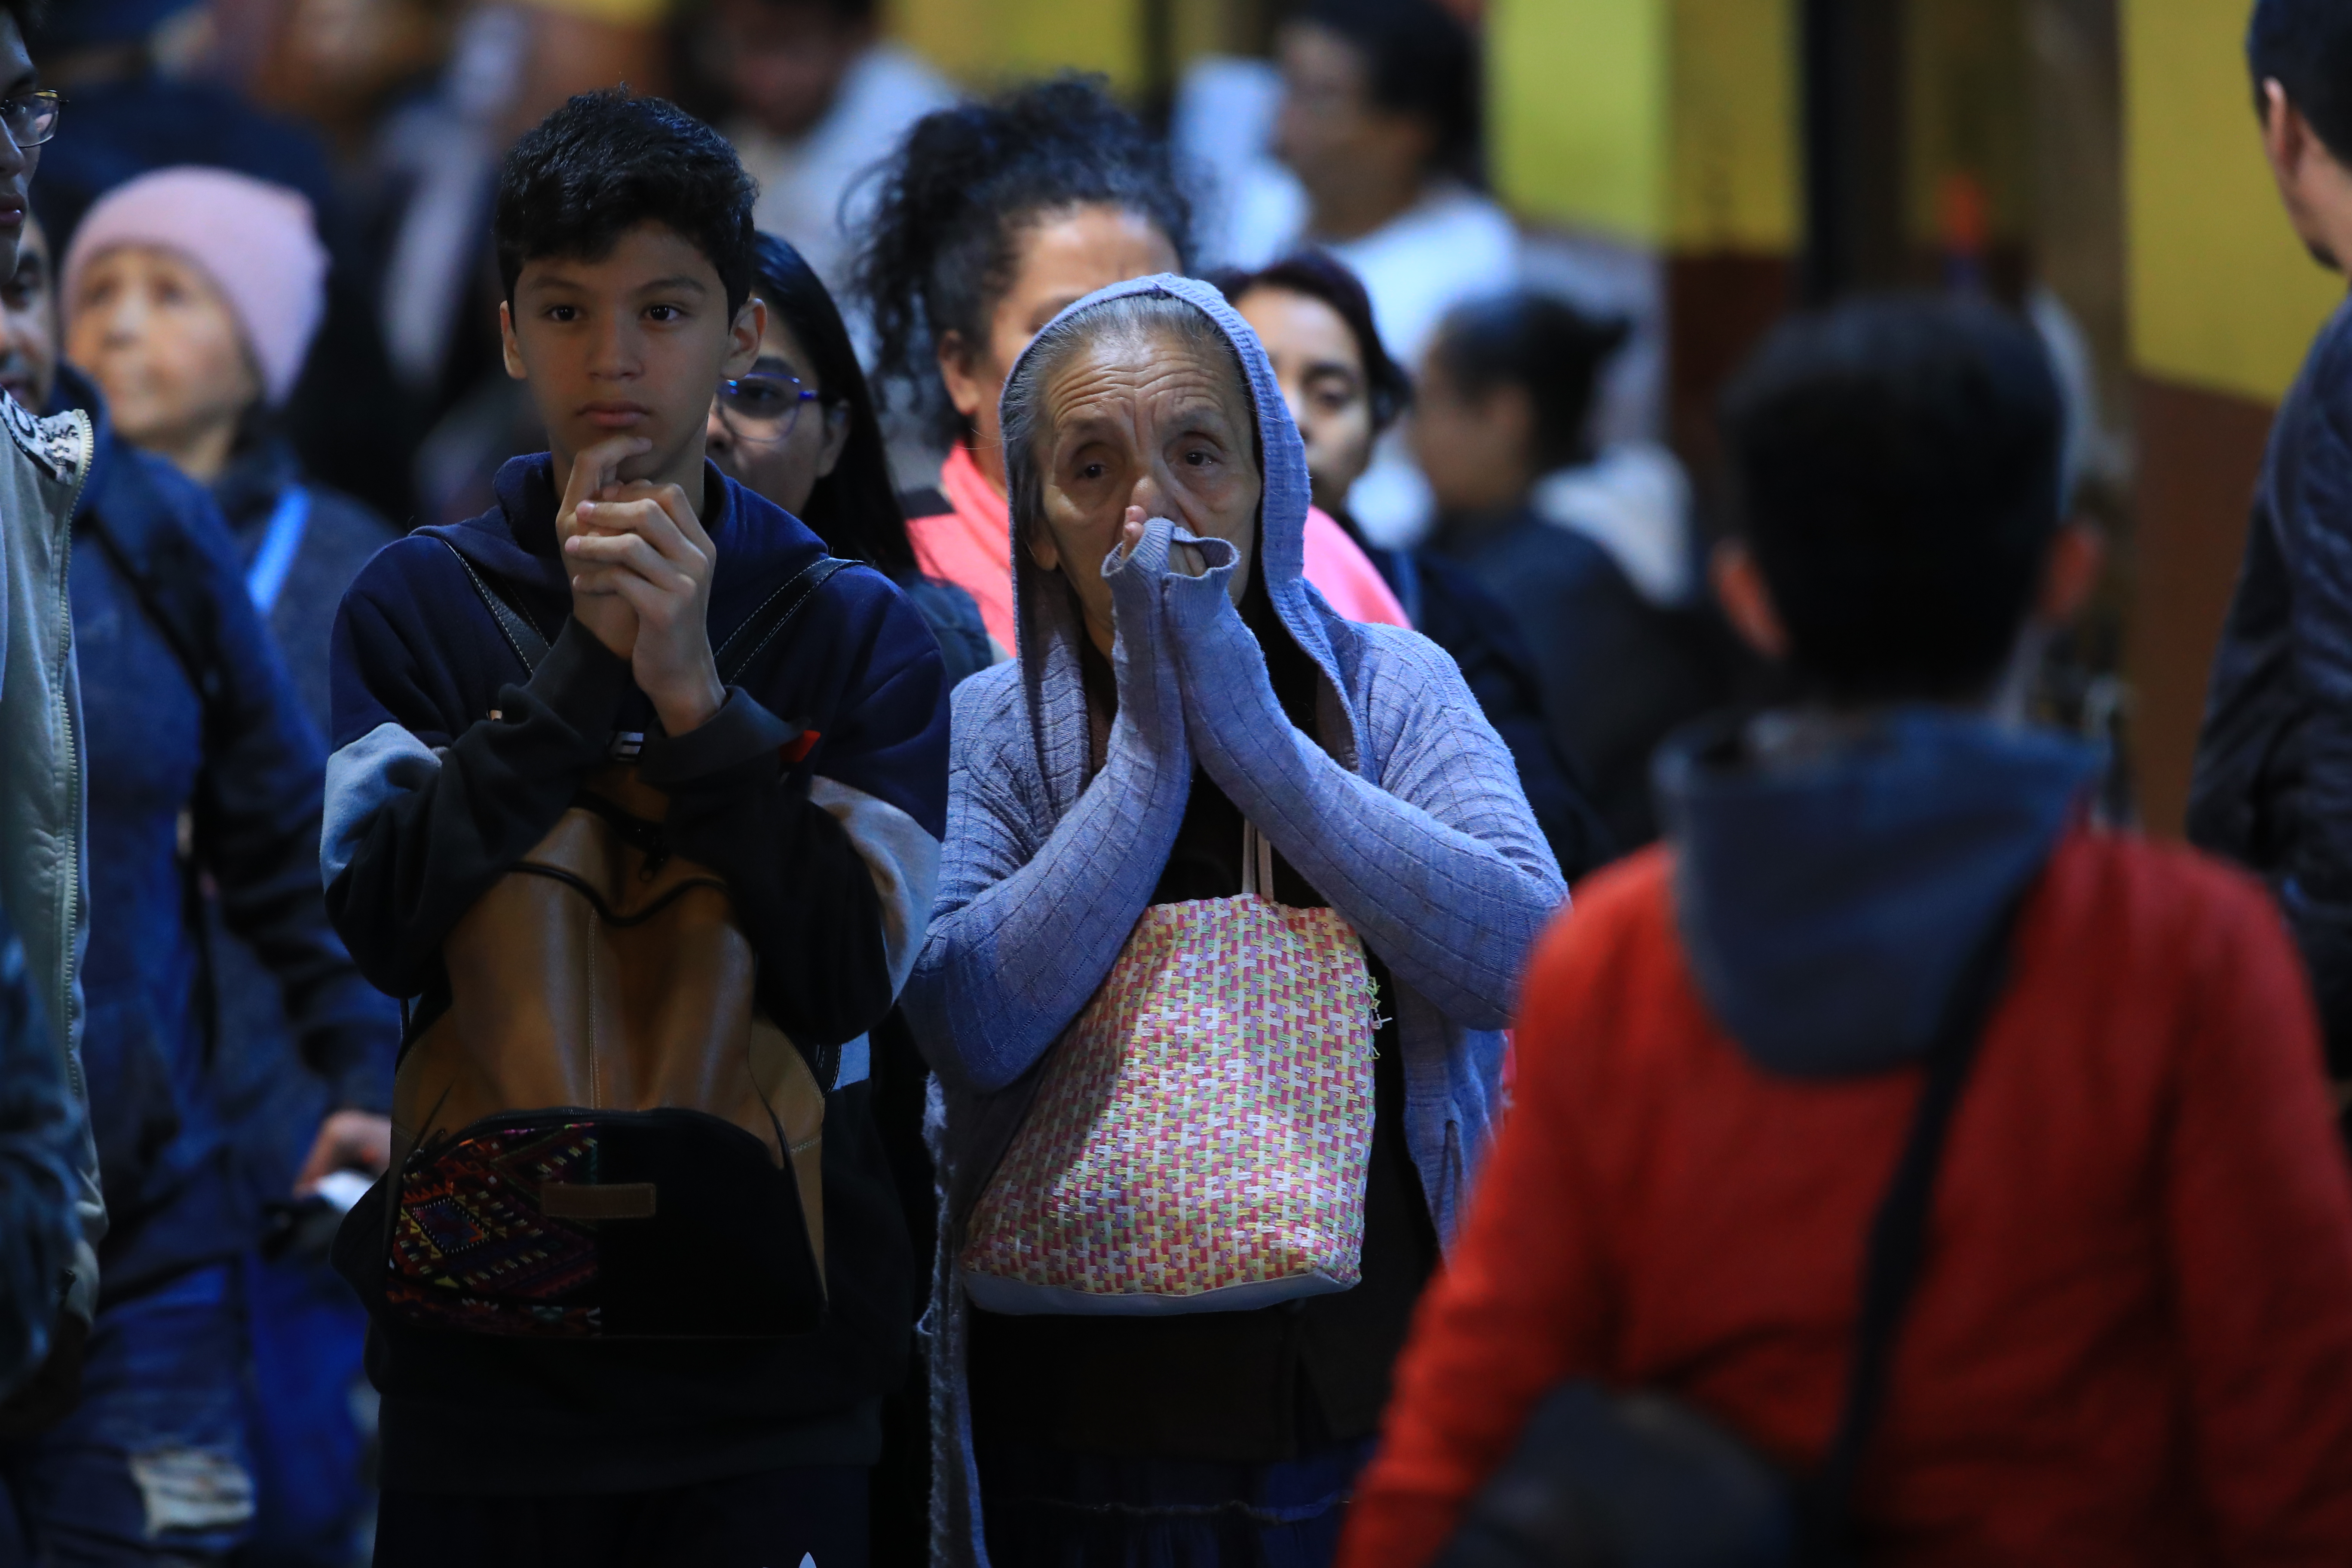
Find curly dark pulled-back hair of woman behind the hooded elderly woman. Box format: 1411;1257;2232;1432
856;75;1192;444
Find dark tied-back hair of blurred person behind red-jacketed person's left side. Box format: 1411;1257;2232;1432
1430;294;1632;472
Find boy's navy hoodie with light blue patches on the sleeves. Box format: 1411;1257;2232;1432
322;454;948;1495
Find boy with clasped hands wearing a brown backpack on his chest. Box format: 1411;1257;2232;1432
325;92;948;1568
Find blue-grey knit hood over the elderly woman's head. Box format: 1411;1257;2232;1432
1000;273;1362;785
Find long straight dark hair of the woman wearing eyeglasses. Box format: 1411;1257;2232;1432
753;235;917;583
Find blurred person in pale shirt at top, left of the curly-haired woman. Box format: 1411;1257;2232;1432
701;0;957;289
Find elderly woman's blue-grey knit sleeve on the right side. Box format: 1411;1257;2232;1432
1164;541;1566;1030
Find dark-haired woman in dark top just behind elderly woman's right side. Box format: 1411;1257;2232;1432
1216;251;1609;882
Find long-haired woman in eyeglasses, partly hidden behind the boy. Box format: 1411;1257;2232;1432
706;235;997;686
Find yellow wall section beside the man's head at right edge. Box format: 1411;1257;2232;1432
2122;0;2345;402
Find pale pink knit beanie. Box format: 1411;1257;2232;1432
66;165;327;407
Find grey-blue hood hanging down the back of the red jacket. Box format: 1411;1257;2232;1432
1658;707;2098;1077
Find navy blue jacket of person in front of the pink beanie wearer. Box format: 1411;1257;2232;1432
56;371;398;1300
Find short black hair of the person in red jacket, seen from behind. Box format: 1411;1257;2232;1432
1724;296;2065;703
